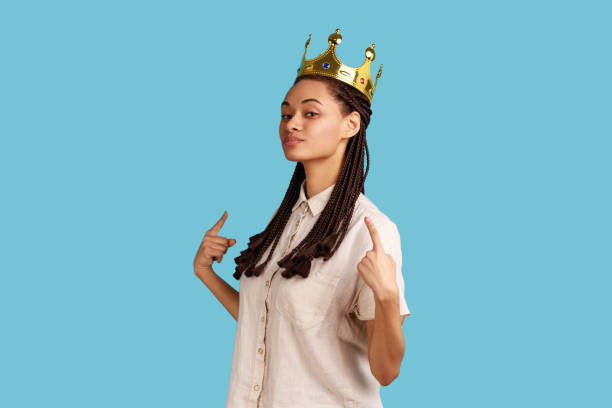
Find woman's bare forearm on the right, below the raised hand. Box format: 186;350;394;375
368;291;404;385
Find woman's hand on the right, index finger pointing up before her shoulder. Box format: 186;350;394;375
357;217;399;298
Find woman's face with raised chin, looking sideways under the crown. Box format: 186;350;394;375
279;79;360;163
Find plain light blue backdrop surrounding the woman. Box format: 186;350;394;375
0;0;612;408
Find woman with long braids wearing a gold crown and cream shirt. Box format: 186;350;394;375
194;30;410;408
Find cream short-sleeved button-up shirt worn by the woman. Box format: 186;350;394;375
225;181;410;408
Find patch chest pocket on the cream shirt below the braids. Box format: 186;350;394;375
274;259;340;330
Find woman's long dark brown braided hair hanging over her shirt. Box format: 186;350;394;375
233;74;372;279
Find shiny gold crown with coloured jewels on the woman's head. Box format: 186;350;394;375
297;28;382;104
